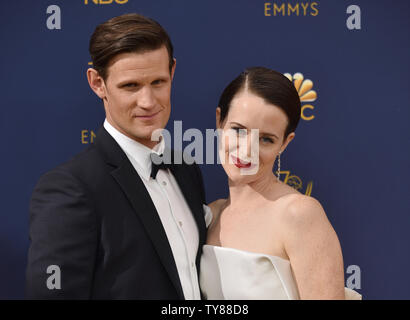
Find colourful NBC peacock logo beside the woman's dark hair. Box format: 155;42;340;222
284;72;317;121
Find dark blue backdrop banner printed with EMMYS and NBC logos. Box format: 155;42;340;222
0;0;410;299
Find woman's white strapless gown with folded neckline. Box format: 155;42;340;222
199;245;362;300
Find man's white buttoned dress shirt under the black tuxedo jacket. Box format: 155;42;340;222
104;119;201;300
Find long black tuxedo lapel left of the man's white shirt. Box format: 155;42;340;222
96;128;184;299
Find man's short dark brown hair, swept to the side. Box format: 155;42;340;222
89;13;174;80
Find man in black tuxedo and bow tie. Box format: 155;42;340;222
27;14;206;299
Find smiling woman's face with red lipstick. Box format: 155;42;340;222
216;90;295;183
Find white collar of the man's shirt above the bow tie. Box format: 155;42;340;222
104;119;165;180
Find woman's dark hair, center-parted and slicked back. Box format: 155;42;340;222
218;67;301;139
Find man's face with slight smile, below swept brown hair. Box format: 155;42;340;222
94;46;175;148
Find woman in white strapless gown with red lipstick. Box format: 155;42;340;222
200;67;360;299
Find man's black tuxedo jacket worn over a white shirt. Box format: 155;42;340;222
26;127;206;299
